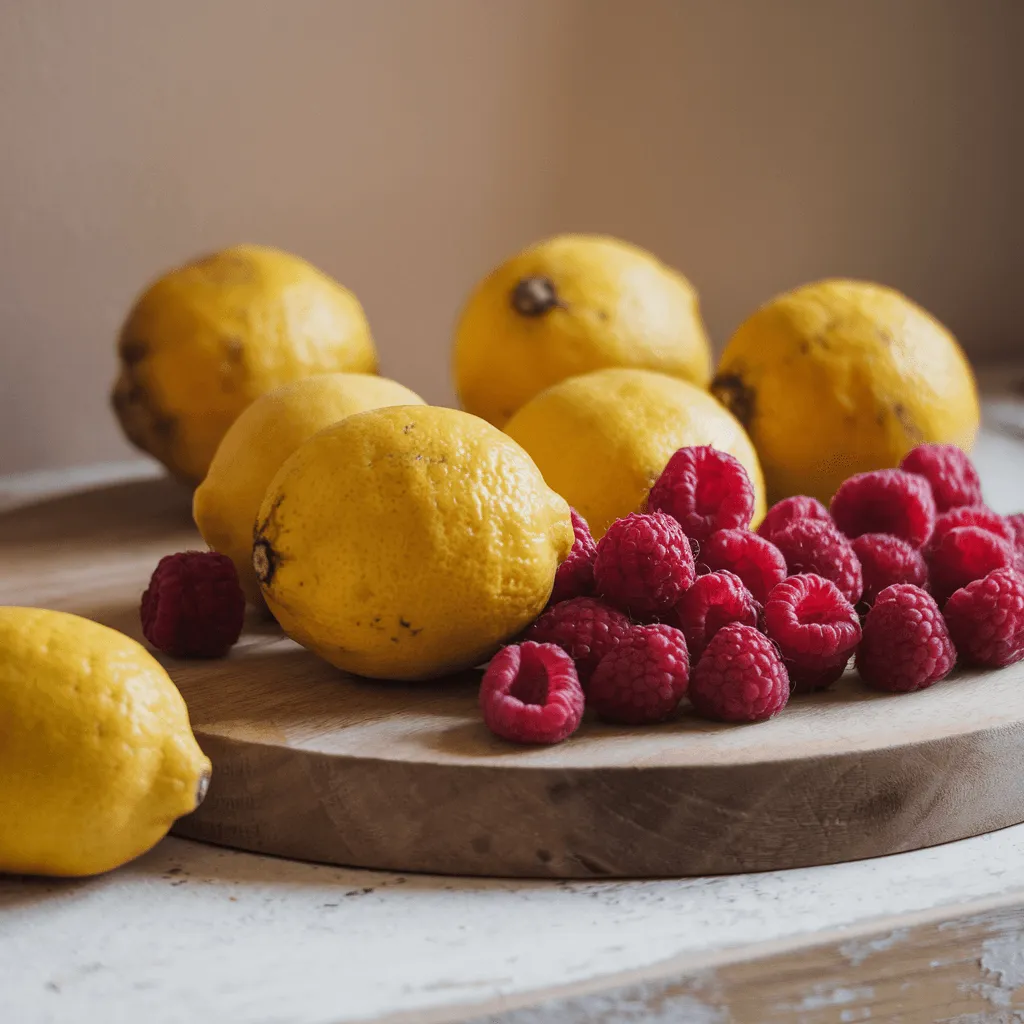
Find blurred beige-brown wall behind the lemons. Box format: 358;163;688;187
0;0;1024;472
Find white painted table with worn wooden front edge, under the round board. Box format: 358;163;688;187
6;385;1024;1024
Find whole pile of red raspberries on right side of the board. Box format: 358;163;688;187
480;444;1024;743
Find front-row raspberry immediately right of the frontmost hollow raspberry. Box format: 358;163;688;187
587;625;690;725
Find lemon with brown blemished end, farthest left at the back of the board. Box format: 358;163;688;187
113;246;377;483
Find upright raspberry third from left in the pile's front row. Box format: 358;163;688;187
690;623;790;722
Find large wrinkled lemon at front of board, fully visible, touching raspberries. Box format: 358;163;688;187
253;406;572;679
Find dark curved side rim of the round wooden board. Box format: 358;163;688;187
174;723;1024;879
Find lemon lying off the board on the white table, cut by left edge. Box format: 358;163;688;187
0;607;210;876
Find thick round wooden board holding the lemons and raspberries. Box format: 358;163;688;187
6;481;1024;878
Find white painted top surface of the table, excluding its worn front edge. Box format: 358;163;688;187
6;378;1024;1024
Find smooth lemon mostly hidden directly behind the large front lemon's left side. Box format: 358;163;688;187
193;374;423;603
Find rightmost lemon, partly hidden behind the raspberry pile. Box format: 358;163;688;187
713;280;979;502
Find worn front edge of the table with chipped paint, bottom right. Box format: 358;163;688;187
362;890;1024;1024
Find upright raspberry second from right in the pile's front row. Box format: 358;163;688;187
856;583;956;693
